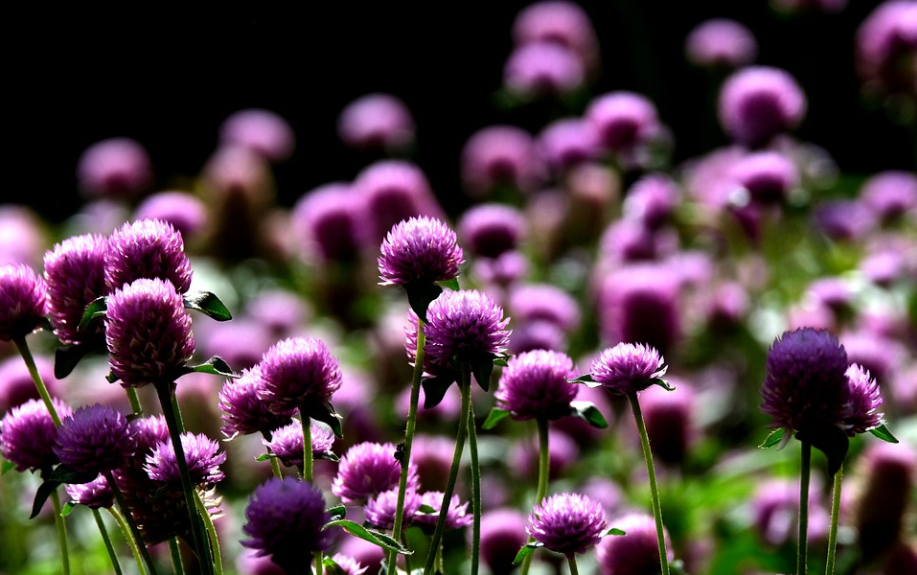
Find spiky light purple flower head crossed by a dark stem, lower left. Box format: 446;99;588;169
144;433;226;489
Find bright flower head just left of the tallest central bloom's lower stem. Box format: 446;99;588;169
331;441;418;503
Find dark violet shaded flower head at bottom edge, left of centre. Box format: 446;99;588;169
242;477;331;573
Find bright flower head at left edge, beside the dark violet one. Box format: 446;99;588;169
0;398;70;473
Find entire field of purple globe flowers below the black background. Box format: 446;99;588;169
0;0;917;575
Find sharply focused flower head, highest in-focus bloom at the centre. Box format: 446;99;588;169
378;217;465;285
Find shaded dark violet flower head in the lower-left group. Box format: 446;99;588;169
54;404;137;474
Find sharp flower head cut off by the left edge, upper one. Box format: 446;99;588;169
0;264;47;341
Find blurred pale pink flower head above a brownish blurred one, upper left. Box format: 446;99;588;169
220;109;296;163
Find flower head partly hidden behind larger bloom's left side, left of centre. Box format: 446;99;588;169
220;365;294;438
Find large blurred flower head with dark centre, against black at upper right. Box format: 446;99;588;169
719;66;806;147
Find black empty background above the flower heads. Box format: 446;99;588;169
0;0;914;225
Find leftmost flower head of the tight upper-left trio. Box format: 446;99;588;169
45;234;108;344
